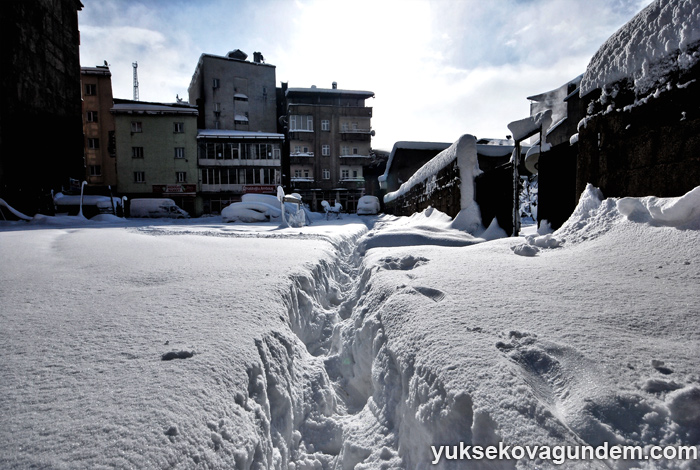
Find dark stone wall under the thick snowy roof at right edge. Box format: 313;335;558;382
576;66;700;197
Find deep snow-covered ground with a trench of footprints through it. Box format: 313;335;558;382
0;188;700;470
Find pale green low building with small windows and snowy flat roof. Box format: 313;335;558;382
111;99;202;215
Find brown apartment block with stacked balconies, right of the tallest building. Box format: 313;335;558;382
285;82;374;212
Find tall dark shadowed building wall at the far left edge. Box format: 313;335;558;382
0;0;85;214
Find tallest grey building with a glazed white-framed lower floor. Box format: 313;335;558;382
188;49;284;213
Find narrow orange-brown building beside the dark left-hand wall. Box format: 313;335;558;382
80;65;117;190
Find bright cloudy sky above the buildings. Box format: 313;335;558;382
79;0;650;150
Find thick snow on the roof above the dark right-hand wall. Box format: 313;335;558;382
580;0;700;96
